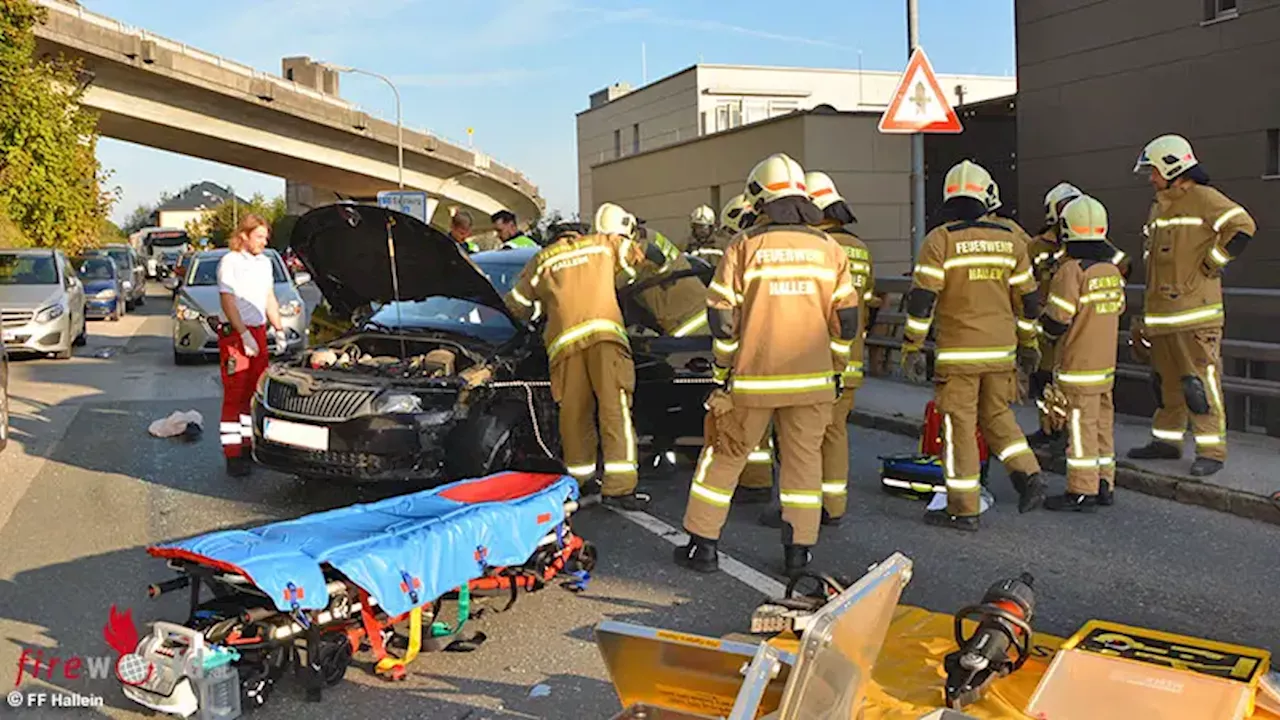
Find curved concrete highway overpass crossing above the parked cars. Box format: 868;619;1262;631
36;0;544;222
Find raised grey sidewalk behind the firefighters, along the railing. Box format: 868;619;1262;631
849;378;1280;524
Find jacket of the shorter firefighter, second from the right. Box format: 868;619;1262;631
1042;258;1125;393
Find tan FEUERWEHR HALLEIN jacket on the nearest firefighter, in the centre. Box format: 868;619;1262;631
707;224;858;407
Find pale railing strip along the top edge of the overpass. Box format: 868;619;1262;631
36;0;532;186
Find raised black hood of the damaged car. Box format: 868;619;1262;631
289;205;525;328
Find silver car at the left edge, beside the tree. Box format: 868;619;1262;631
0;250;88;360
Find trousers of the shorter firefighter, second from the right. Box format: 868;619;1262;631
1064;388;1116;495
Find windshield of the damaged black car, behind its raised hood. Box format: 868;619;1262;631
370;259;525;343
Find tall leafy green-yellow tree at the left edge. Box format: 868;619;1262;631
0;0;115;251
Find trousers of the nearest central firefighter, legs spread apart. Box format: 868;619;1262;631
685;402;831;546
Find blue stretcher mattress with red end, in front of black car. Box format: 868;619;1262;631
148;473;579;616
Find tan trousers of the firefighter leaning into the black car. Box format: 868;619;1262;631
552;342;636;496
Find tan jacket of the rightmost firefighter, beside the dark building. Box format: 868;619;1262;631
1143;184;1257;337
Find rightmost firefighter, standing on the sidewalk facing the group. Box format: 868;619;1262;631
1129;135;1257;478
